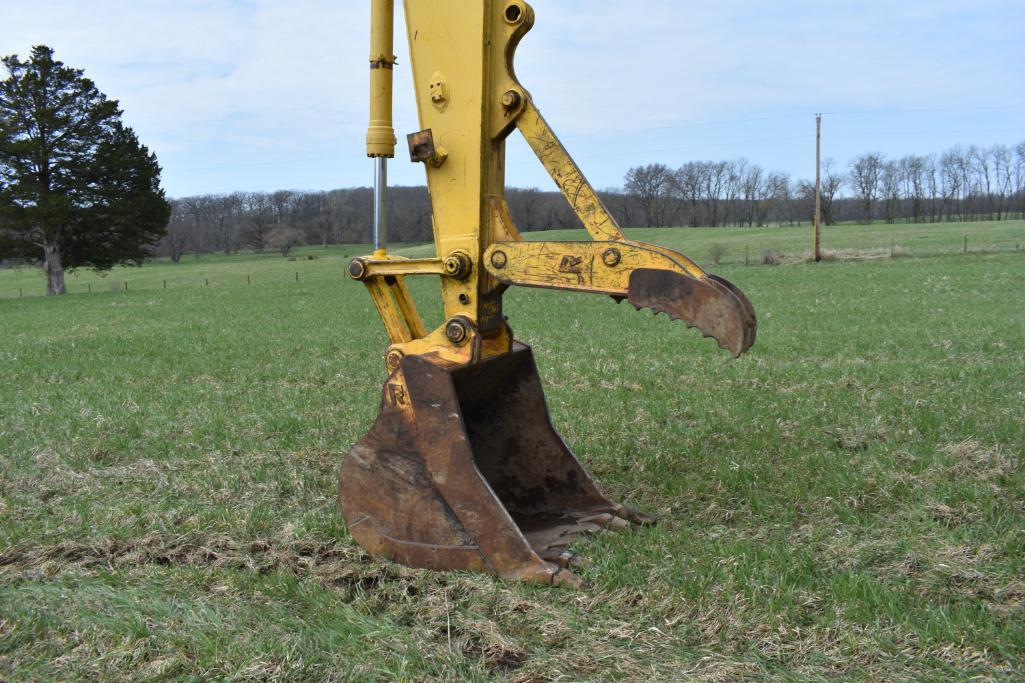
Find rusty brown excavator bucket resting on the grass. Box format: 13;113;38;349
338;343;654;586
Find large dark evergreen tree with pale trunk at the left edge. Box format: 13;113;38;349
0;45;170;294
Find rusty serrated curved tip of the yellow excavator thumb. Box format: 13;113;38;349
627;268;757;357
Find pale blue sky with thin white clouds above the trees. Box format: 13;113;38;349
0;0;1025;197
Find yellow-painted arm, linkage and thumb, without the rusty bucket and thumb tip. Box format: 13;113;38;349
360;0;725;362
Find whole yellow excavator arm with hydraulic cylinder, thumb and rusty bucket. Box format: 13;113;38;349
338;0;756;587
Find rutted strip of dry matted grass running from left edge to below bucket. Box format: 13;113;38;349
0;534;549;680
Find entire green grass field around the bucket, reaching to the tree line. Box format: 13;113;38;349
0;222;1025;681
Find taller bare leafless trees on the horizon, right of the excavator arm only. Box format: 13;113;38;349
623;142;1025;228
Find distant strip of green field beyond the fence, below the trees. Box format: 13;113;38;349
0;216;1025;298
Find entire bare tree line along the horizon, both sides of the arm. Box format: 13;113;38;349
157;142;1025;262
